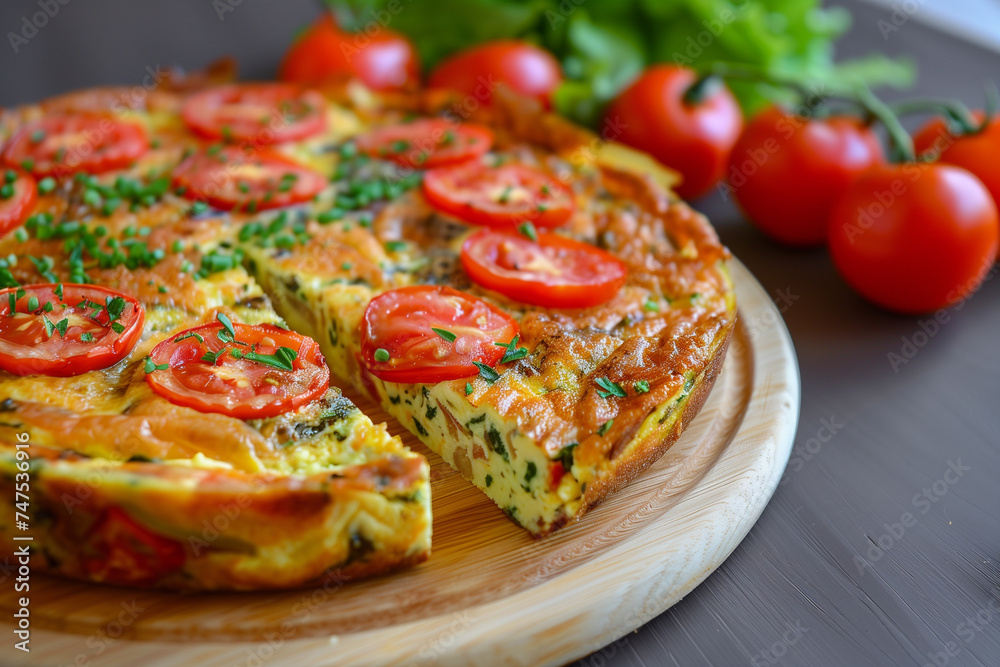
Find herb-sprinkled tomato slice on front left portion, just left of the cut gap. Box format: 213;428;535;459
146;322;330;419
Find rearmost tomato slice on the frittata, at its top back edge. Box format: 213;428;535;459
181;83;326;145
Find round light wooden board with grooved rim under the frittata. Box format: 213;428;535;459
0;261;799;667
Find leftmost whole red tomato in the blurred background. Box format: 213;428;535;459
278;13;420;90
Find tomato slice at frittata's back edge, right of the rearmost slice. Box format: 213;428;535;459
355;118;493;169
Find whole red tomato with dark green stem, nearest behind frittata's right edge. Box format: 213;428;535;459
605;65;743;199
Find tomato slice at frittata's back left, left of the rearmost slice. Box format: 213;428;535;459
3;114;149;176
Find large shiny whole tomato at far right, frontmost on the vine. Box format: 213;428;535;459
829;164;1000;313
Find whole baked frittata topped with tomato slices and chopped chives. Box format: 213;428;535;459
0;66;736;589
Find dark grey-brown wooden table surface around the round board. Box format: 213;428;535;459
0;0;1000;667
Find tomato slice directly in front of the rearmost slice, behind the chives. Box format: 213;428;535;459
174;146;327;213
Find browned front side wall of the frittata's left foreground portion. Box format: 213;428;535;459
0;447;428;591
